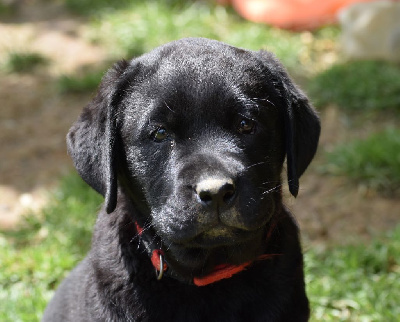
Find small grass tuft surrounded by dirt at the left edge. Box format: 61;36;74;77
4;51;49;73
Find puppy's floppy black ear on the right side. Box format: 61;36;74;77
257;51;321;197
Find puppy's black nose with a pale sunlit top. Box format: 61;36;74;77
195;178;236;207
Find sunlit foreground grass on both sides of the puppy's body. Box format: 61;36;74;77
0;174;400;322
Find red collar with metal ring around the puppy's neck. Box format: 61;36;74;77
135;222;281;286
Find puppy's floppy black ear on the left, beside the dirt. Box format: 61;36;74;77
67;61;129;213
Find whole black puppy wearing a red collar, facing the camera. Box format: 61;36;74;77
43;39;320;322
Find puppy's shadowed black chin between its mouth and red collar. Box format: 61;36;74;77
161;229;266;281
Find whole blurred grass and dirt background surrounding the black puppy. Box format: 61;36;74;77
0;0;400;322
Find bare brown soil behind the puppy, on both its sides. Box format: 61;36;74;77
0;2;400;243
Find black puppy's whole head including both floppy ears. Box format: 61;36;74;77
68;39;320;276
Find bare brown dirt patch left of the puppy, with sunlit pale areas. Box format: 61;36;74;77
0;2;106;228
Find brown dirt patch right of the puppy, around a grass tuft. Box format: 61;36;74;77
289;107;400;244
